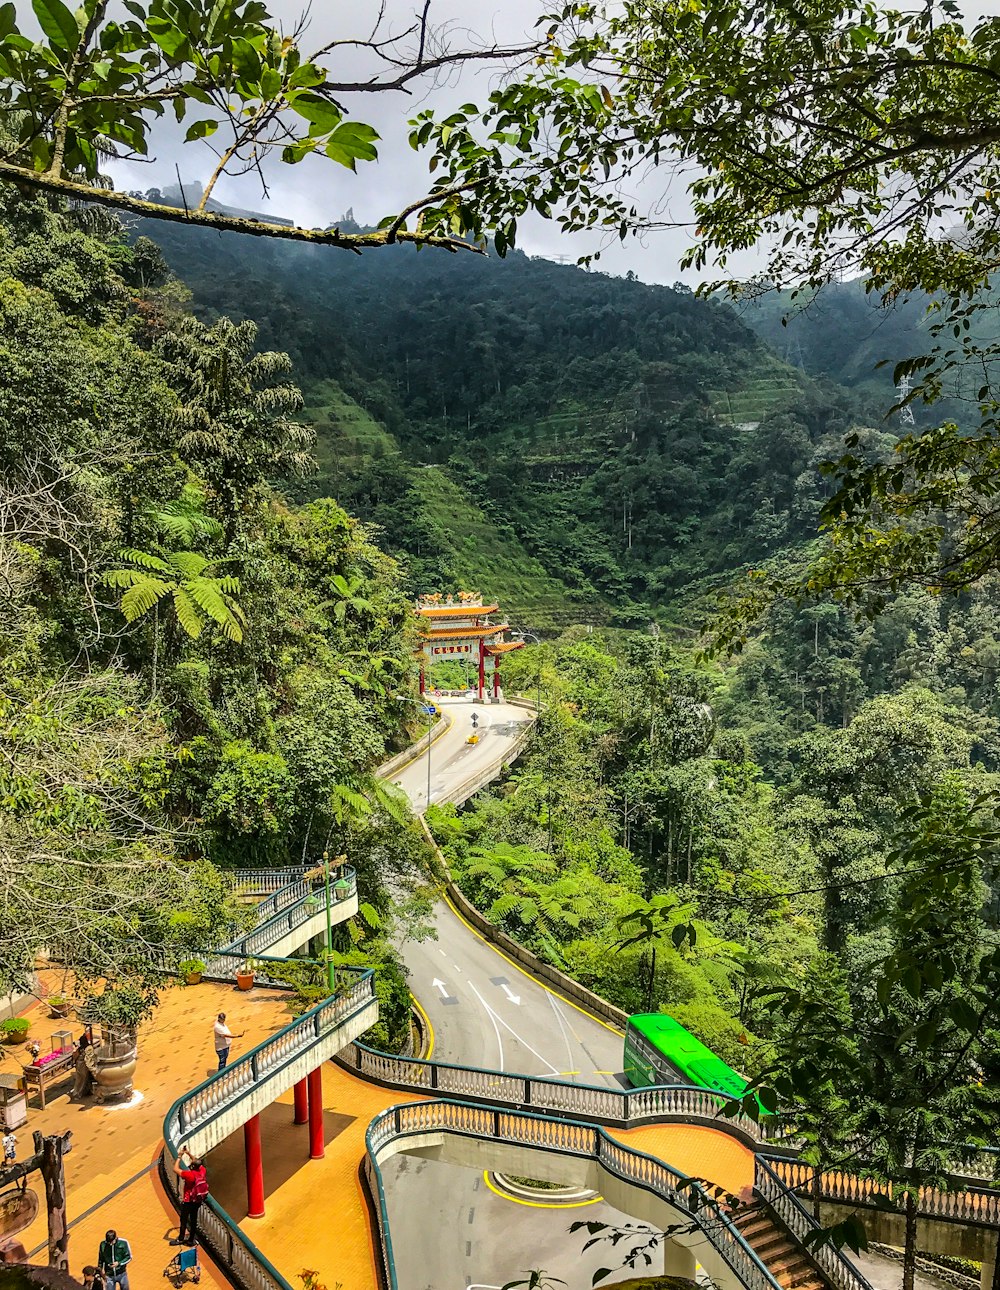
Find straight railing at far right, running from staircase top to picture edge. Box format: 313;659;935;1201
766;1157;1000;1227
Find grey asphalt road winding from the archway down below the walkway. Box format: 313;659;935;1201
383;699;630;1290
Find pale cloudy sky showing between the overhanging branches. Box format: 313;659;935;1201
103;0;769;283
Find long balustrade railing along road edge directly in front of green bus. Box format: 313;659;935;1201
338;1041;770;1144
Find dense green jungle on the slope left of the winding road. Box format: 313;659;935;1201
0;188;419;1042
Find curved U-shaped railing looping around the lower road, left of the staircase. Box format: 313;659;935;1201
365;1102;781;1290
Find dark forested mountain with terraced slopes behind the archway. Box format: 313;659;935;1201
134;211;865;628
